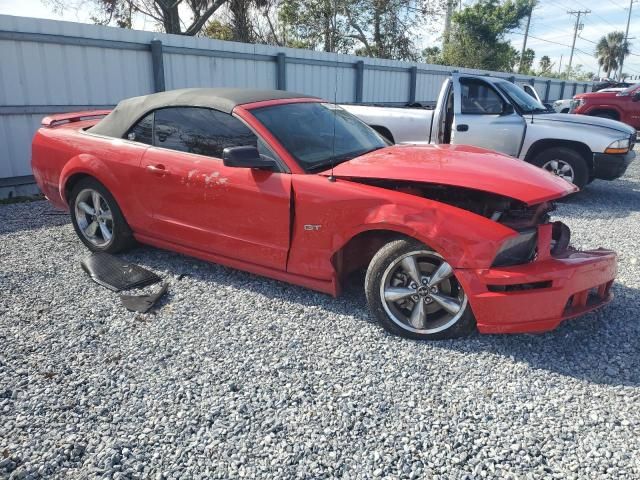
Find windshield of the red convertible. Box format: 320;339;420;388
251;102;388;172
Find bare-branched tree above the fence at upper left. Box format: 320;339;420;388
43;0;228;35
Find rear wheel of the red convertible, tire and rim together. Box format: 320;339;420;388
69;178;135;253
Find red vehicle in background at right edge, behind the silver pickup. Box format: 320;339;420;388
570;83;640;129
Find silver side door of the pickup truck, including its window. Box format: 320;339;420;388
451;76;525;157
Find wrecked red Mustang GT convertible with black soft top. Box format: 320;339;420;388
32;89;616;338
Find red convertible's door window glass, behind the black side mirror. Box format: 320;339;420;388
153;107;258;158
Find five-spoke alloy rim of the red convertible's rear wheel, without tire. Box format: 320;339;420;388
74;188;113;247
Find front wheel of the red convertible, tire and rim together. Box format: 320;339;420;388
365;239;476;340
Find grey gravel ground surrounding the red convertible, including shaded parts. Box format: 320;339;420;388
0;161;640;479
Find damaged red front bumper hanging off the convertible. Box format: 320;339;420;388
456;225;617;333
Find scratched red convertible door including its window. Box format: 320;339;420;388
139;107;291;270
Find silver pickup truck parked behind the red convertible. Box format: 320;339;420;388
342;73;636;188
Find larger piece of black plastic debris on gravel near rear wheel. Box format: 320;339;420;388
81;253;161;292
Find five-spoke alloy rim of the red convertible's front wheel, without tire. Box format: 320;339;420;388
380;250;467;334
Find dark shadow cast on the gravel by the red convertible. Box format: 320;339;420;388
121;247;640;386
